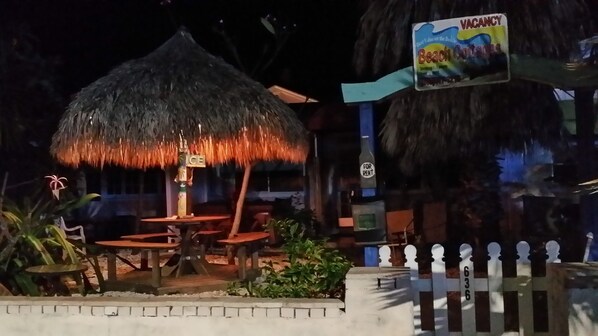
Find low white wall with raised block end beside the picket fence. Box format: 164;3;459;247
0;268;413;336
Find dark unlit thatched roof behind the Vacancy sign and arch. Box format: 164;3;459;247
354;0;592;170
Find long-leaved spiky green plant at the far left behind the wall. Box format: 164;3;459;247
0;182;99;295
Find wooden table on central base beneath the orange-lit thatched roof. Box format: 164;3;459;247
141;215;230;277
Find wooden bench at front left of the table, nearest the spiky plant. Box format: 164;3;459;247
96;240;179;288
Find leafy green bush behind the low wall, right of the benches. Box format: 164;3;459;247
234;219;351;298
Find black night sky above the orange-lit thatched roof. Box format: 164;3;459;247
0;0;362;101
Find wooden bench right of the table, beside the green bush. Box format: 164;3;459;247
218;232;270;280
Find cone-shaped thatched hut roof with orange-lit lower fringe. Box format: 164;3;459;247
51;29;308;168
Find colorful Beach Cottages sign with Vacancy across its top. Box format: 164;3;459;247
413;14;510;91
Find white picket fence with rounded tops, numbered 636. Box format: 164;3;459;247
379;241;560;336
